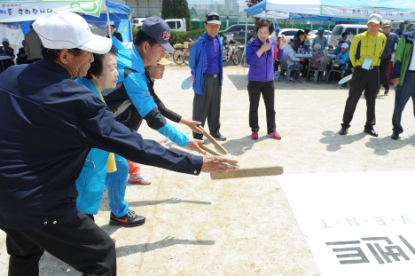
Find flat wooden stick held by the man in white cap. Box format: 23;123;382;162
210;166;284;180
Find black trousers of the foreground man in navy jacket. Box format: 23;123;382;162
1;213;117;276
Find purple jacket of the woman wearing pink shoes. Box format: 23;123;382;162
246;37;283;82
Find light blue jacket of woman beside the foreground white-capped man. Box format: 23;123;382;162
76;78;109;215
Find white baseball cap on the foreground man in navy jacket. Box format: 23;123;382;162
33;12;112;54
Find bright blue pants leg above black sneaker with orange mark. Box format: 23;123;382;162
105;154;130;217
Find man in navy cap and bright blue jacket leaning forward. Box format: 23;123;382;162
104;17;205;227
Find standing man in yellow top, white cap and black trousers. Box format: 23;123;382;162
339;13;386;137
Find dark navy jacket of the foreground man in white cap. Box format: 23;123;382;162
0;59;202;229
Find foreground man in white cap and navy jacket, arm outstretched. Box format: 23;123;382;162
0;12;237;275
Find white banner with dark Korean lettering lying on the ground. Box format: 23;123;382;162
277;172;415;276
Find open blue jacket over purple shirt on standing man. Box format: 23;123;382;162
189;32;223;95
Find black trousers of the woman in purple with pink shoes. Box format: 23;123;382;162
248;80;277;133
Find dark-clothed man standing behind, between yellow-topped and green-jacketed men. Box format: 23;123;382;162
379;21;399;95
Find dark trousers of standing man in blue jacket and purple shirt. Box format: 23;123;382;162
193;74;222;139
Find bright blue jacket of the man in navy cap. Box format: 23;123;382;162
112;37;189;147
